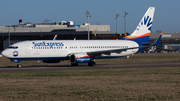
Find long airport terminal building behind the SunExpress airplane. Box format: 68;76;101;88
0;21;180;52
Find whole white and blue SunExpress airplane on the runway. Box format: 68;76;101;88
1;7;163;68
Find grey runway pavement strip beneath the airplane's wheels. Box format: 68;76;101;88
0;62;180;73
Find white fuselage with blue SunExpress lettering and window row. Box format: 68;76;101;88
2;40;139;60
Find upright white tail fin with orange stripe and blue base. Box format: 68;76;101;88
123;7;155;42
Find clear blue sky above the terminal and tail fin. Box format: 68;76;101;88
0;0;180;33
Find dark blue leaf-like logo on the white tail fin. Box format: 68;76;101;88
136;16;152;31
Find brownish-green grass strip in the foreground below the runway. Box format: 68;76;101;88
0;67;180;101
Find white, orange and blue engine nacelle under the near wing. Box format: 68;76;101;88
70;53;91;63
